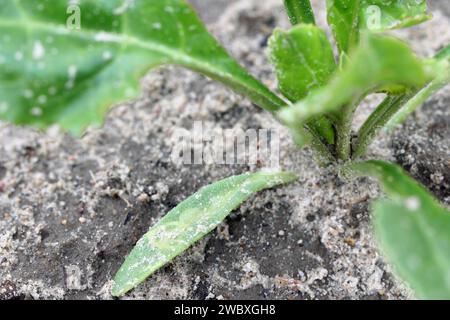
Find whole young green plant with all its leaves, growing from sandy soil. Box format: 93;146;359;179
0;0;450;298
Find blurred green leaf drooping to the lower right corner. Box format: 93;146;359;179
350;161;450;299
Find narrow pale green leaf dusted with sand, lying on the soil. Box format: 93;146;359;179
112;172;296;296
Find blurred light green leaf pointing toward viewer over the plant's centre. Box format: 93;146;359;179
279;33;434;135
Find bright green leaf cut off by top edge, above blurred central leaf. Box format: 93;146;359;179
327;0;432;52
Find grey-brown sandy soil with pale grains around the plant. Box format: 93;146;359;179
0;0;450;299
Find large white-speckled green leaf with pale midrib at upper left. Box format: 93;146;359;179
0;0;285;134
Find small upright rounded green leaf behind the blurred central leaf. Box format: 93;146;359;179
269;24;336;144
